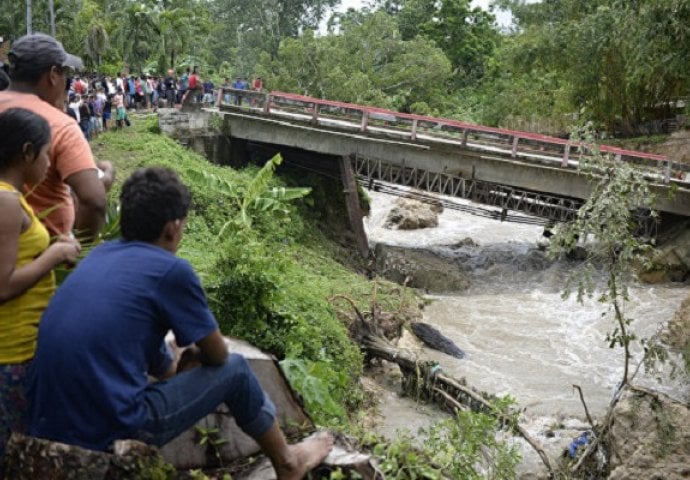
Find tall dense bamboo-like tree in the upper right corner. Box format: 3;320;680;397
496;0;690;132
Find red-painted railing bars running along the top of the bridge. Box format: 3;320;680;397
216;89;673;183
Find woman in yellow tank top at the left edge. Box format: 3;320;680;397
0;106;80;468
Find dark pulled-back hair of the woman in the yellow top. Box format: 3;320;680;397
0;108;50;171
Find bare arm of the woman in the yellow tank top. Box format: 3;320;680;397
0;194;81;304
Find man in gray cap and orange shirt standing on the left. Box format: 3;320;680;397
0;33;114;237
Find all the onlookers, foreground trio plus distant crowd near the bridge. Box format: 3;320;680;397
0;34;333;479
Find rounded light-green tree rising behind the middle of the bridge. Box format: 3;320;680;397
260;12;451;113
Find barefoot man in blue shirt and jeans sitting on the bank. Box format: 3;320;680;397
29;168;333;479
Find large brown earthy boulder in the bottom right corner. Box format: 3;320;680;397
608;390;690;480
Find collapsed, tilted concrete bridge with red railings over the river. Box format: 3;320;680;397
160;89;690;255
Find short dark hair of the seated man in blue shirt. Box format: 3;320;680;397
120;167;191;242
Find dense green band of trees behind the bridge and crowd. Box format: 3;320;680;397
0;0;690;134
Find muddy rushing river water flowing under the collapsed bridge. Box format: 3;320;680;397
365;192;690;432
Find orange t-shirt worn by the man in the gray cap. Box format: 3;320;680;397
0;90;96;235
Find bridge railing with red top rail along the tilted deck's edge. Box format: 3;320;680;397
217;89;676;183
